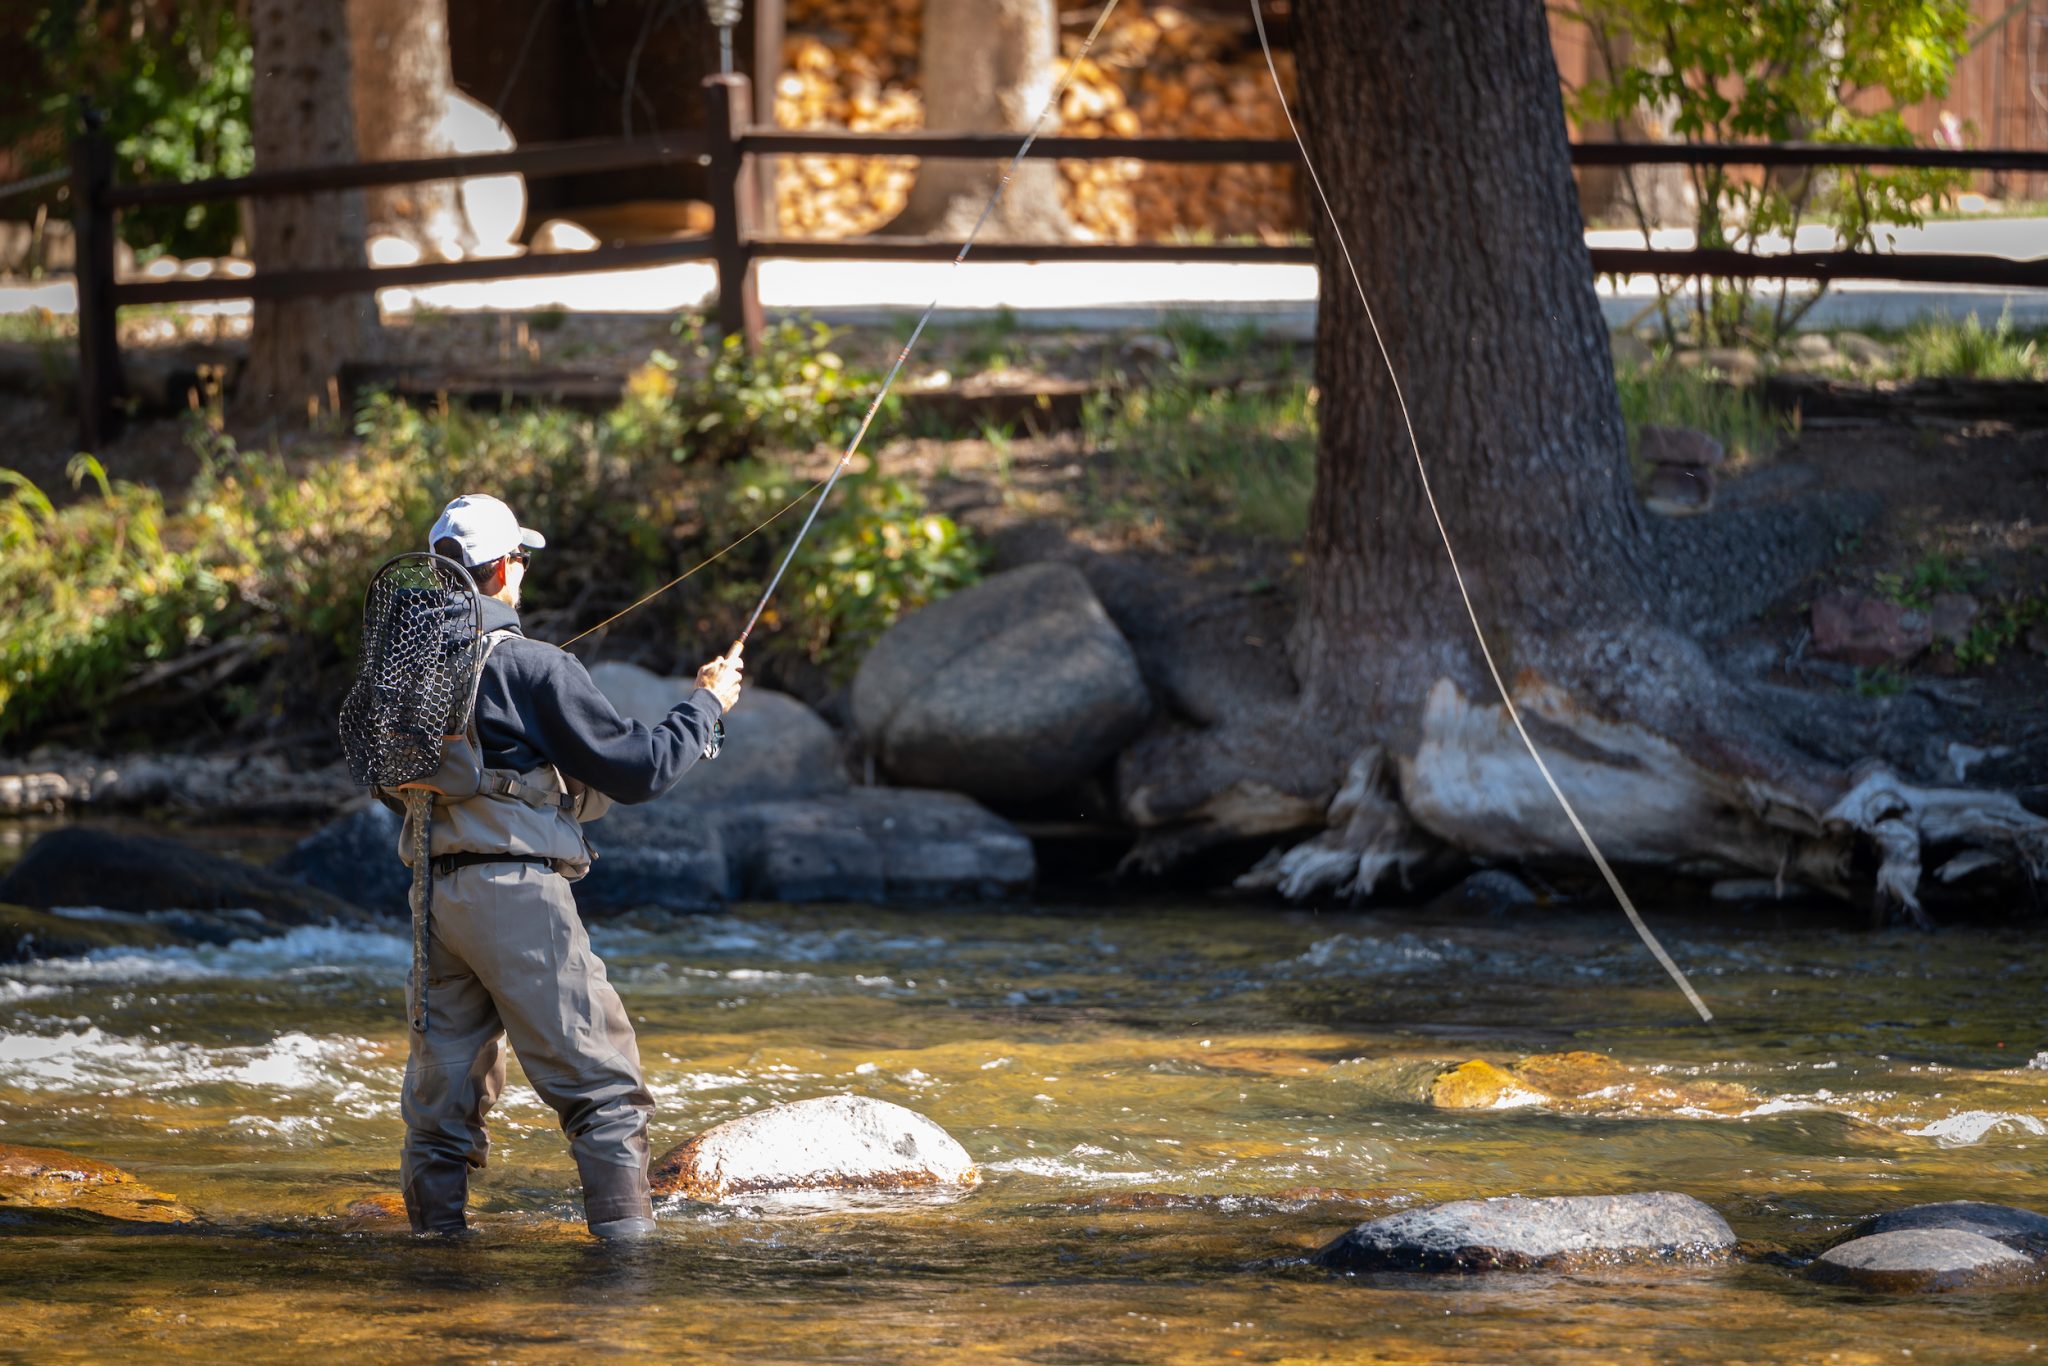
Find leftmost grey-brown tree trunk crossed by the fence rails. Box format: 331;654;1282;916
240;0;377;418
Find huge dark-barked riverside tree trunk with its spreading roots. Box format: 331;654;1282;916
1122;0;2048;925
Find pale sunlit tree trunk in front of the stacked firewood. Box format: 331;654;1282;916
883;0;1073;242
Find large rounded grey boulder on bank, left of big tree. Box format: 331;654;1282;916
852;563;1151;801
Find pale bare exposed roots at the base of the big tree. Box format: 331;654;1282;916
1241;678;2048;922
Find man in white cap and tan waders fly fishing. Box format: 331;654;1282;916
356;494;741;1239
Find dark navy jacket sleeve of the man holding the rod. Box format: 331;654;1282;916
528;651;723;805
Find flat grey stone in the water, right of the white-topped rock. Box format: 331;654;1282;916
1315;1190;1735;1272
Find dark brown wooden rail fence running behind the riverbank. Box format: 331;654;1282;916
0;74;2048;451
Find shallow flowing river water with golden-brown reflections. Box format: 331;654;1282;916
0;880;2048;1362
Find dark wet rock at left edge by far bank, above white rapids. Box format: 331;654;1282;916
0;825;362;926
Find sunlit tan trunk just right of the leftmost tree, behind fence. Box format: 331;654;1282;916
348;0;473;260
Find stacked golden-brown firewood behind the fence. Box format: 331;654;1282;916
774;0;1305;242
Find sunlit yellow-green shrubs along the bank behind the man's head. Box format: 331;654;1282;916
0;366;979;741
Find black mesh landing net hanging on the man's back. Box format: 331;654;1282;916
342;551;483;788
